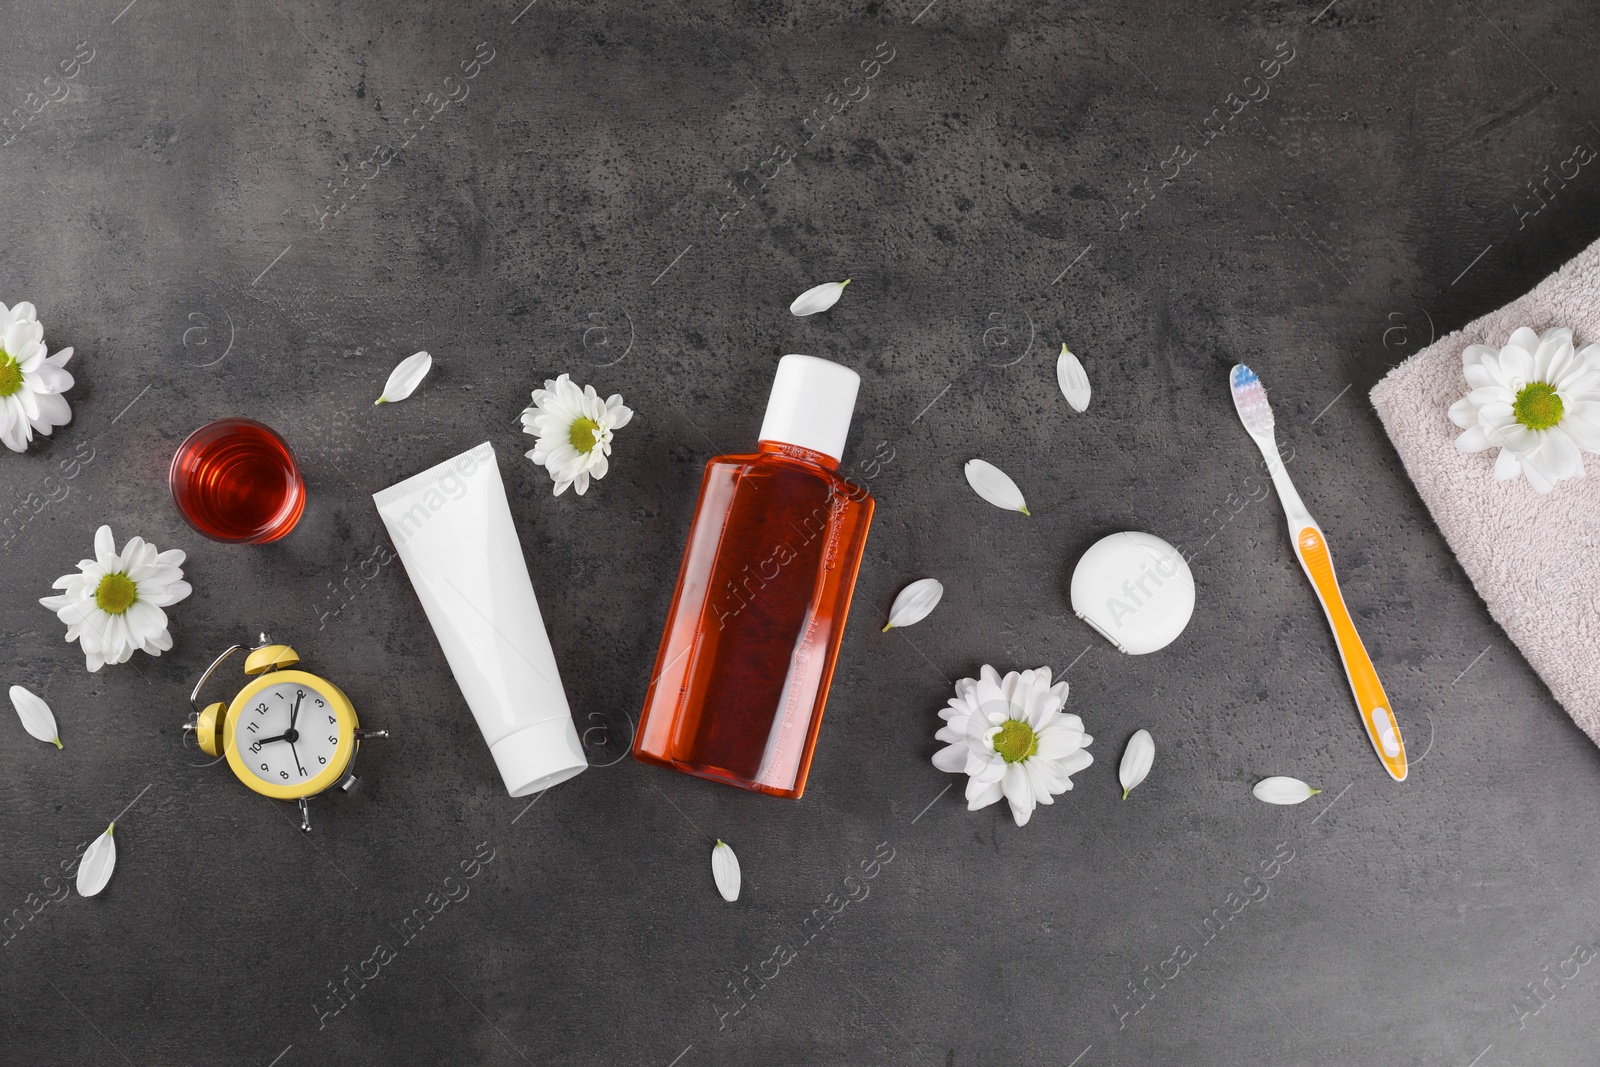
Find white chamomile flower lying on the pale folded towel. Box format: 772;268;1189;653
1450;326;1600;493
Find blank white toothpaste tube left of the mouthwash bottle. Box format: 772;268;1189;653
373;442;589;797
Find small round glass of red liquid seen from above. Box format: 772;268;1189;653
168;419;306;544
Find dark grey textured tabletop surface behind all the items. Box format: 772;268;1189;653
0;0;1600;1067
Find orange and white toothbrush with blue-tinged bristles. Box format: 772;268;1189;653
1227;363;1406;782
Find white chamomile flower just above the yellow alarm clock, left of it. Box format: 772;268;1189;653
38;526;190;672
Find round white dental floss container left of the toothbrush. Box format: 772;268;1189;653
1072;530;1195;656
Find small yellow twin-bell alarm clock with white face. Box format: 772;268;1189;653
184;633;389;832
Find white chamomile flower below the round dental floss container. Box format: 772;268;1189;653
933;664;1094;825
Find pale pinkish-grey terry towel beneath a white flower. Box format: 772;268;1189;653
1373;242;1600;744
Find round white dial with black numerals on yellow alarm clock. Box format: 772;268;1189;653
234;681;339;787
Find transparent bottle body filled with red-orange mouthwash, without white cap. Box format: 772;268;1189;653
634;442;874;797
